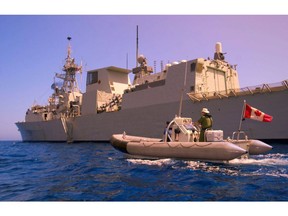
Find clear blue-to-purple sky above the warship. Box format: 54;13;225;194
0;0;288;140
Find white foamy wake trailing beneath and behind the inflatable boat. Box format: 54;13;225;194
127;154;288;179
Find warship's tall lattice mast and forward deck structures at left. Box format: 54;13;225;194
25;37;82;122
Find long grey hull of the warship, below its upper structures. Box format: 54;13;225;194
16;90;288;142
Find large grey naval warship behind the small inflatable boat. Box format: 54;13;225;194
16;37;288;142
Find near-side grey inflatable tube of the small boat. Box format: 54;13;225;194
110;134;247;161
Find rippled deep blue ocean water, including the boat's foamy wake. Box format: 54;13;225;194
0;141;288;201
